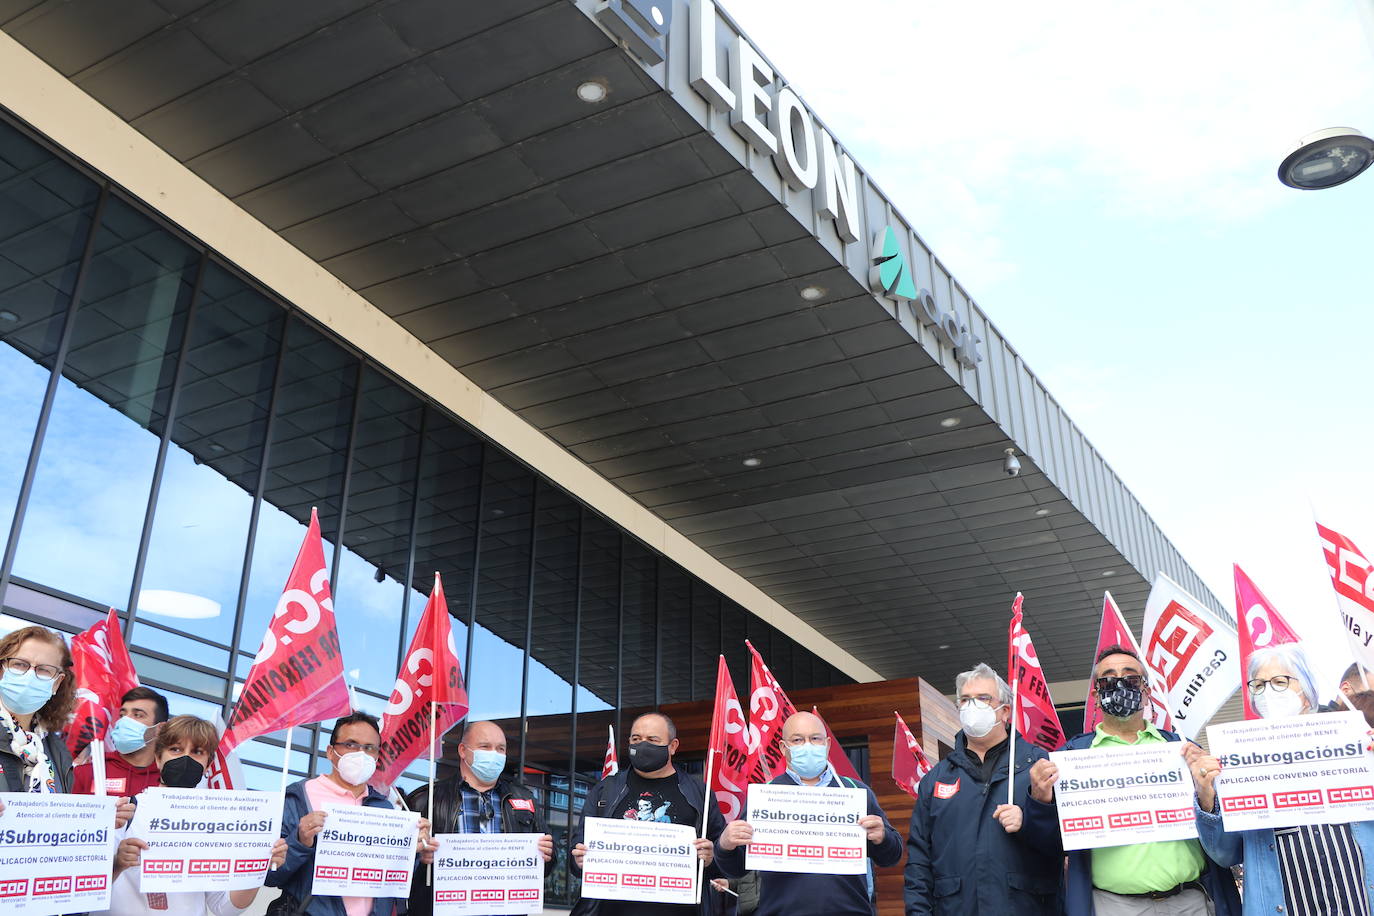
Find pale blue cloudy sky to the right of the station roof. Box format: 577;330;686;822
721;0;1374;684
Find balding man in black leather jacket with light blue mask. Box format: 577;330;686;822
405;722;554;916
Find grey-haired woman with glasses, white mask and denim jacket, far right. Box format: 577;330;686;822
1187;643;1374;916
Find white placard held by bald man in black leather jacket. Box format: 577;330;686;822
434;834;544;916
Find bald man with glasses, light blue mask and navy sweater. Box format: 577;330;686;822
717;713;901;916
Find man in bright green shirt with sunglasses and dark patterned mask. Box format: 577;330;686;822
1028;645;1241;916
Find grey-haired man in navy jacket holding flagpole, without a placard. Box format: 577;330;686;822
905;663;1063;916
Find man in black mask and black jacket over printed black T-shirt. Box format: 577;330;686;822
572;713;725;916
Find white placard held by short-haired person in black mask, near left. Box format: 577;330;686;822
128;788;282;894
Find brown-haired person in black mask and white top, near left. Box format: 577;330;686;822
91;715;286;916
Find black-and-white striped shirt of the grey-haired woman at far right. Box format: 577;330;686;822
1274;824;1370;916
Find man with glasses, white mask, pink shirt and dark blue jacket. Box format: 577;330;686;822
265;711;434;916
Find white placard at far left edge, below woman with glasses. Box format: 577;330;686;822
0;792;114;916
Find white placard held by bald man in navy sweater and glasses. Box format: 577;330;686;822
745;783;868;875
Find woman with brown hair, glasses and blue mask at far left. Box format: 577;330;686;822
0;626;76;792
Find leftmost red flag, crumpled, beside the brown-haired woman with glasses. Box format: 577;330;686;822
66;607;139;757
